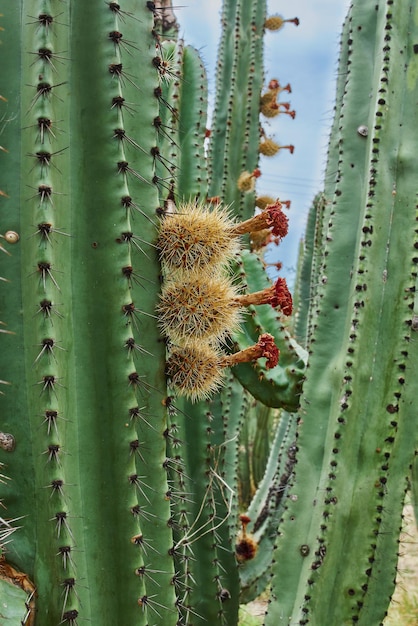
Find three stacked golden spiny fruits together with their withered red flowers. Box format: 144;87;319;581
157;201;291;401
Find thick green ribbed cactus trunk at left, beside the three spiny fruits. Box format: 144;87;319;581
1;0;177;626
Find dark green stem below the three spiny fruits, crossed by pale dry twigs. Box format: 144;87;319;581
165;386;242;624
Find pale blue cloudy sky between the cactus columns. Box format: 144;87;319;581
173;0;349;283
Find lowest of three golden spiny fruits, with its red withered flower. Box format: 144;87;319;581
166;333;279;402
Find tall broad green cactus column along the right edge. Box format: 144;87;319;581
265;0;418;626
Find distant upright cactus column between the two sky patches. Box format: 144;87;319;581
209;0;266;219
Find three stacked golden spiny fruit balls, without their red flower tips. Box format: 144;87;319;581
157;203;240;401
